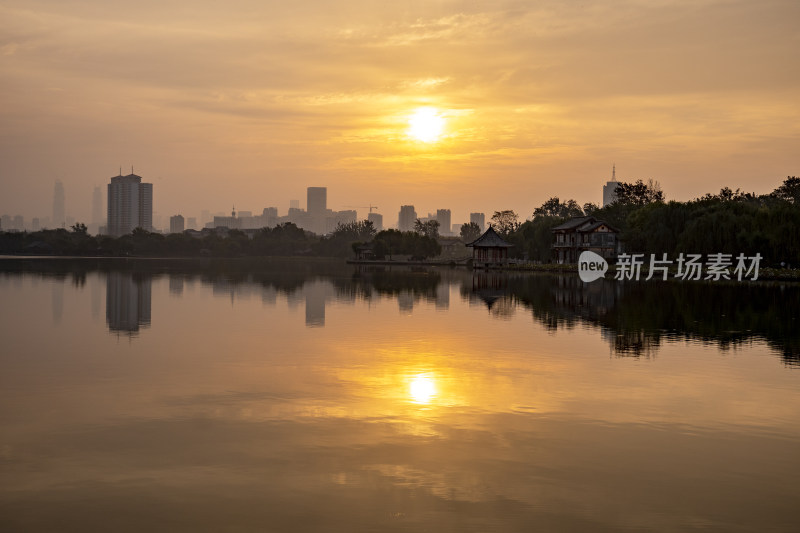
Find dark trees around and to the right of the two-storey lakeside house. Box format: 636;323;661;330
492;176;800;266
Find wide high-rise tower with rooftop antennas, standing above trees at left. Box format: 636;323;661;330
107;173;153;237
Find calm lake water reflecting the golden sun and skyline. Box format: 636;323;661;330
0;259;800;532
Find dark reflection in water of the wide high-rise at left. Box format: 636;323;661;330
106;272;152;336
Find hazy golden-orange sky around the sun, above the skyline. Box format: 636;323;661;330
0;0;800;226
